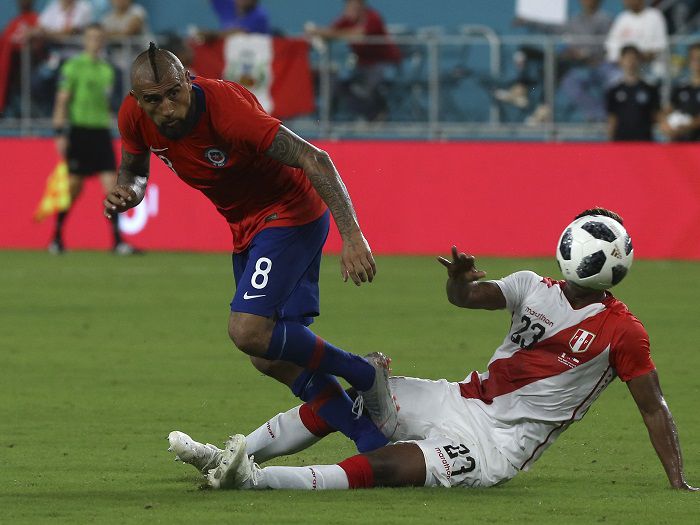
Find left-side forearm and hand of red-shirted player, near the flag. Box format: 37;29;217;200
103;147;150;219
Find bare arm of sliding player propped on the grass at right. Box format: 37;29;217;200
627;370;698;492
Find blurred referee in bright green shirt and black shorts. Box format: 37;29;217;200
49;24;138;255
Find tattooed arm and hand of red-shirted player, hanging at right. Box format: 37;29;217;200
266;126;377;286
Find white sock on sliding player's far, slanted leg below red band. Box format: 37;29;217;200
245;406;321;463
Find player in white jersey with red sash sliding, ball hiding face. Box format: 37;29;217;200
169;208;698;491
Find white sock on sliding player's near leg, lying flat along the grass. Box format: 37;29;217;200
250;465;350;490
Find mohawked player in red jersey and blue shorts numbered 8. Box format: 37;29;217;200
104;44;390;451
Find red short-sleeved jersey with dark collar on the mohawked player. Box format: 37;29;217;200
119;77;326;252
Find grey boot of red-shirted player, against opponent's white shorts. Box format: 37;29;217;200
360;352;399;439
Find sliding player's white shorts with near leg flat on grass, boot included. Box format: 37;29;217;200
207;384;518;490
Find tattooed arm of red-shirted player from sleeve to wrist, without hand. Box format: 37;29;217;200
266;126;358;235
